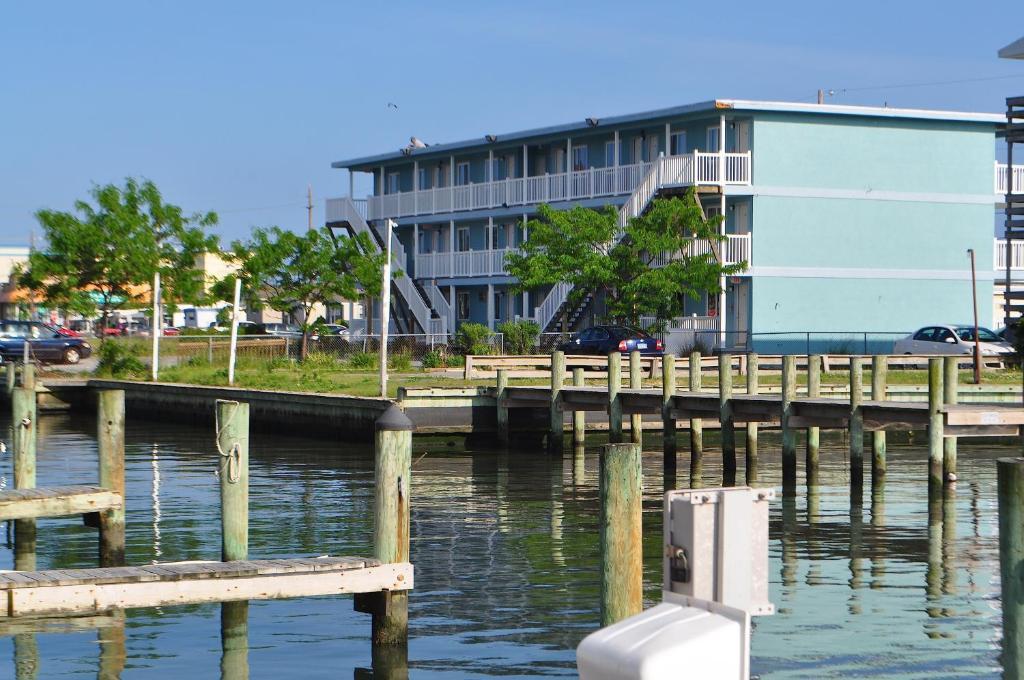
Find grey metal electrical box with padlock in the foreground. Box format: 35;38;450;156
663;486;775;615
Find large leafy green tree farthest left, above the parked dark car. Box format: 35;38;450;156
17;177;217;331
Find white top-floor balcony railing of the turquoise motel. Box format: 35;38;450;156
366;152;751;220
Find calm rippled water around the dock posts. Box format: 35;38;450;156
0;416;1011;678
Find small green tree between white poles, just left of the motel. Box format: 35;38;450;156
214;226;386;358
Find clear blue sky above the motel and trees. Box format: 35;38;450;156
0;0;1024;244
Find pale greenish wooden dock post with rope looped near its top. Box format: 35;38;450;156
216;399;249;562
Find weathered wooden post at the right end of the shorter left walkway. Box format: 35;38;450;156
96;389;125;566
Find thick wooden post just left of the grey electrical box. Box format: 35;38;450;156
600;443;643;626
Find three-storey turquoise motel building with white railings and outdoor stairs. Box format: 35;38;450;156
327;99;1024;351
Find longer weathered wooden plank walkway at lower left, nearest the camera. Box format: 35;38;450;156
0;557;413;621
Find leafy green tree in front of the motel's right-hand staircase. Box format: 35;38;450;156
506;189;743;328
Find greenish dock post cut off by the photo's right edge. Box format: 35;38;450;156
996;458;1024;678
